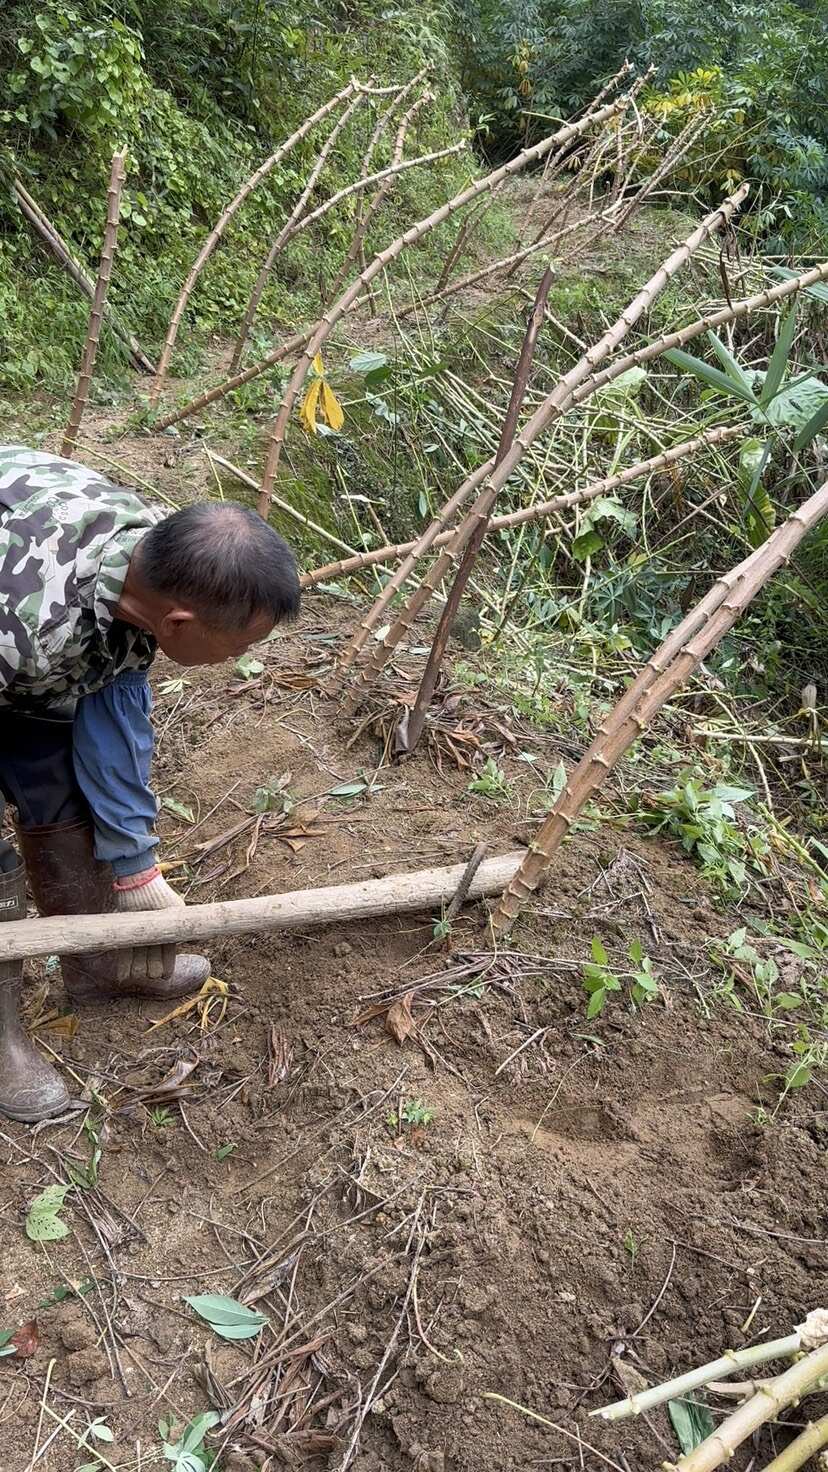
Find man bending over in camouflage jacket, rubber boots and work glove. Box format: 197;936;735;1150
0;446;299;1122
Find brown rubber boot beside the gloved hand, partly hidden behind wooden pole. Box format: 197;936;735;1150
18;820;209;1002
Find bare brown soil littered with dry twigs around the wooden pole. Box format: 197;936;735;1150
0;585;828;1472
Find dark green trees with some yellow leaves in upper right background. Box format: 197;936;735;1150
453;0;828;250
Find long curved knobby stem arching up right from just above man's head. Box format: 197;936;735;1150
254;102;623;514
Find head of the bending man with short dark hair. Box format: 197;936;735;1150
118;500;299;664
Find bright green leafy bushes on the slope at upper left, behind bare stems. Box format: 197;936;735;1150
0;0;469;387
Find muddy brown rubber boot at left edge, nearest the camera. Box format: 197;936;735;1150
0;864;69;1125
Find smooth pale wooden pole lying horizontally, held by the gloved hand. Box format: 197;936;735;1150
0;849;523;963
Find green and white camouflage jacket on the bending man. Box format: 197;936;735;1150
0;445;165;717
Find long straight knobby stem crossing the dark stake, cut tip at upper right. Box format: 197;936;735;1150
338;185;747;712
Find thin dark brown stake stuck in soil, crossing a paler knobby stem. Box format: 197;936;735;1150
396;266;552;752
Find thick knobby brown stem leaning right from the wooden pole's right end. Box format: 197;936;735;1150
491;481;828;941
